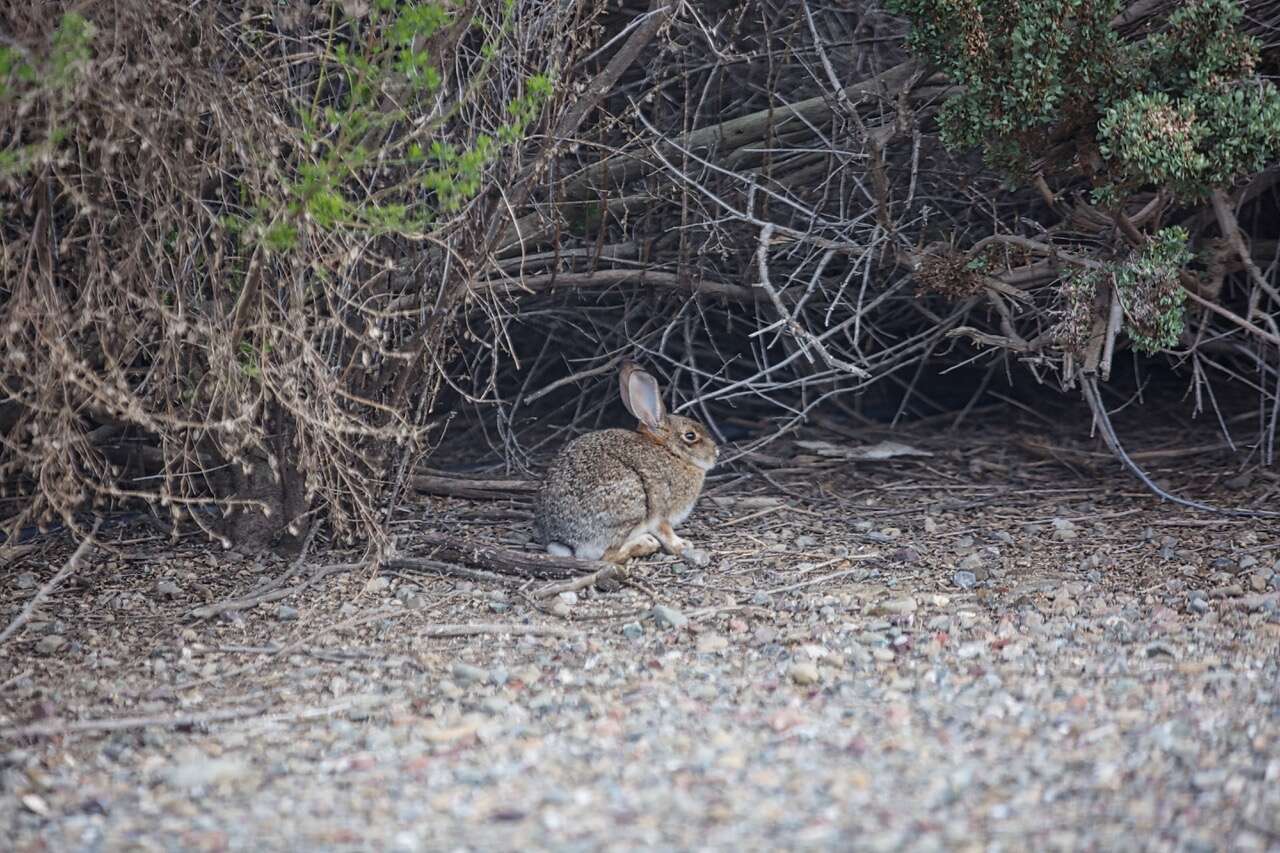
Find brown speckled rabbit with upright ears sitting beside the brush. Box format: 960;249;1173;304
534;361;719;566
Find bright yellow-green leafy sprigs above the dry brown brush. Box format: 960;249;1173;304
244;0;553;252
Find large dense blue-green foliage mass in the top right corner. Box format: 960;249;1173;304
890;0;1280;195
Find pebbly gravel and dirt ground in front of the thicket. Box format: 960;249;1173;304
0;412;1280;850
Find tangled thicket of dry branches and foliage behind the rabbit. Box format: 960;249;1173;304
0;0;1280;546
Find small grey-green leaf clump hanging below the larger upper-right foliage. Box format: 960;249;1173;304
1111;227;1192;353
